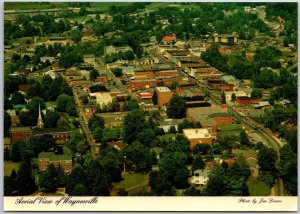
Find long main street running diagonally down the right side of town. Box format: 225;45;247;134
147;49;286;196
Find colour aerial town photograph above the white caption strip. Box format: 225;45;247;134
3;2;298;197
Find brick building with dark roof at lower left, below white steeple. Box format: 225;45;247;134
38;147;72;174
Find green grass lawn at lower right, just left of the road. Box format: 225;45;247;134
247;178;271;196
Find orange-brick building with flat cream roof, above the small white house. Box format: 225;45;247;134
182;128;213;147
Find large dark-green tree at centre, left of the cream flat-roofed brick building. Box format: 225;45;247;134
124;109;145;143
